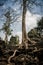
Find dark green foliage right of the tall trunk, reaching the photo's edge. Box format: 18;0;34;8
28;17;43;38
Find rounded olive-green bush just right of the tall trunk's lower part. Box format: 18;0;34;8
28;27;41;42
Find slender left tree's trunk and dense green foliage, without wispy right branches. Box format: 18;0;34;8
0;11;12;44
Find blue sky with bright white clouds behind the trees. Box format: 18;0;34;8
0;0;43;42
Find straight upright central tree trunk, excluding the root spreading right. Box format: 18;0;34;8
22;0;27;49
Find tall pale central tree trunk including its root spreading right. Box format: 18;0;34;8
22;0;36;49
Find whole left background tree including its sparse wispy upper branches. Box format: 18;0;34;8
0;7;19;44
